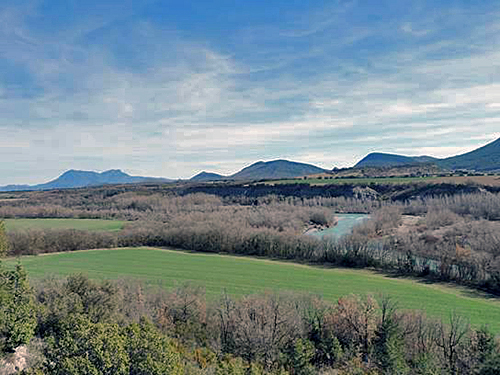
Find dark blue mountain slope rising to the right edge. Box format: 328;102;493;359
438;138;500;172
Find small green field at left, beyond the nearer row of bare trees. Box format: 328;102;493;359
4;219;124;232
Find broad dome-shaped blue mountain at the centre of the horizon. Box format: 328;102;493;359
229;160;325;180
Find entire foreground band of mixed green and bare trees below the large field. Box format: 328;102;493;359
0;268;500;375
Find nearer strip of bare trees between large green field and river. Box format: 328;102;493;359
8;214;500;294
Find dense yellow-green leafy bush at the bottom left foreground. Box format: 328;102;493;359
39;308;183;375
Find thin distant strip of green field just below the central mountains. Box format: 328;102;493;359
266;177;441;185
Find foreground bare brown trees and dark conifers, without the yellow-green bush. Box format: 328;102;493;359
24;275;500;374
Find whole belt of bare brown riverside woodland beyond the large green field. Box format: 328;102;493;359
0;192;500;294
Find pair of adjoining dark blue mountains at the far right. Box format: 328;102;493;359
355;138;500;172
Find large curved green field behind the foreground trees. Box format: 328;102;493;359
6;248;500;333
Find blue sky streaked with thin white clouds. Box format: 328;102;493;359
0;0;500;185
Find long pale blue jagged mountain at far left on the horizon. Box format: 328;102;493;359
0;169;172;191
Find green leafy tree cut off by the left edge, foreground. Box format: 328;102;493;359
0;264;36;351
